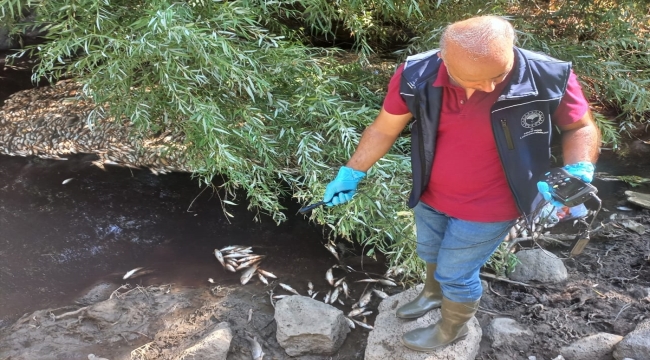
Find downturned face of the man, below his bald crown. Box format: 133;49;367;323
443;44;514;92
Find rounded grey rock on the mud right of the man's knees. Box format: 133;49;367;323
509;249;568;283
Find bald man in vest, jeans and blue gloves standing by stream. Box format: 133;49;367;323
323;16;600;351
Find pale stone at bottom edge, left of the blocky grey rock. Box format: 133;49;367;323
179;322;232;360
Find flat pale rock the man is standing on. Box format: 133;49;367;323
364;285;483;360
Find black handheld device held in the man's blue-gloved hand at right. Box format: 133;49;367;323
544;168;598;207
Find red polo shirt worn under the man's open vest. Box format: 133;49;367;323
384;63;589;222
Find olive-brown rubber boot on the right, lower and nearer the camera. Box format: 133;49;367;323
402;297;479;351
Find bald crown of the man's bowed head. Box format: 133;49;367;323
440;16;516;61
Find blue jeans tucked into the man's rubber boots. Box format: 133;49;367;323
414;201;515;302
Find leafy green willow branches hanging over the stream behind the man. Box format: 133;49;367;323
0;0;650;282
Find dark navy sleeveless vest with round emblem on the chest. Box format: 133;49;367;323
400;47;571;215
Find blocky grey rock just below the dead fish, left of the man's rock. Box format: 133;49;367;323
275;295;350;356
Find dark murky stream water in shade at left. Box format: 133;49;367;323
0;155;372;326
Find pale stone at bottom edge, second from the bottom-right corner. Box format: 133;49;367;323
560;333;623;360
